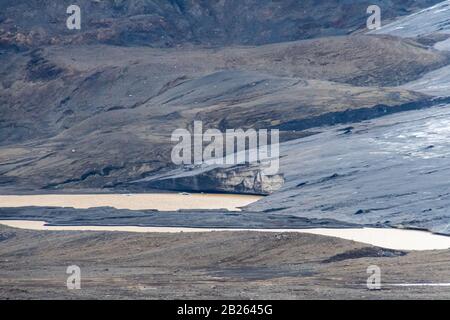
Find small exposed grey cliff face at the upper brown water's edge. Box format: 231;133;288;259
137;165;284;195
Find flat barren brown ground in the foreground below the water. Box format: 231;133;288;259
0;226;450;299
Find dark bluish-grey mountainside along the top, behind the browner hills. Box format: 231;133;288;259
0;0;439;48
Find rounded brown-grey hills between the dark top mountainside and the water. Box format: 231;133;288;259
0;36;448;189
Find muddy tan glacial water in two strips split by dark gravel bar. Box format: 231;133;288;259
0;193;450;250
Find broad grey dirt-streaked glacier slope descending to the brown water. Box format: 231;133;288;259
246;104;450;235
